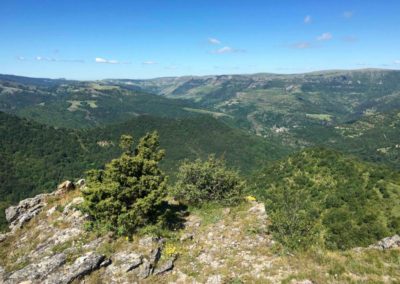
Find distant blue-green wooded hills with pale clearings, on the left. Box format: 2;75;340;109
0;75;196;128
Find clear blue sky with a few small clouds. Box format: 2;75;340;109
0;0;400;79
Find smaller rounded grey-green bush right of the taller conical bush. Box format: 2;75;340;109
173;155;245;206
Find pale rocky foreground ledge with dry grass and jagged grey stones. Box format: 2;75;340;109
0;181;400;284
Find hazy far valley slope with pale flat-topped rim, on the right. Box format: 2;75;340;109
116;69;400;146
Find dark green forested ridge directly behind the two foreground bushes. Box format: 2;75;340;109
0;112;288;230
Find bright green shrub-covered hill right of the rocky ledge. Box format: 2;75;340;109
257;148;400;250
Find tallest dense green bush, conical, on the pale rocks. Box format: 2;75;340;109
83;132;166;235
